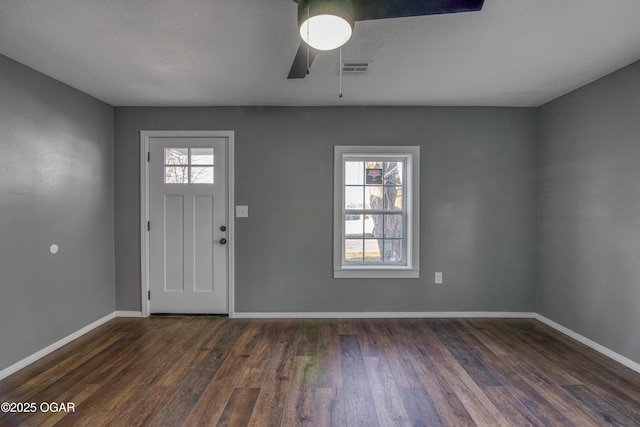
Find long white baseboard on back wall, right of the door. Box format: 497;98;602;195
233;311;536;319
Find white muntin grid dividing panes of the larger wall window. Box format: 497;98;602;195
341;154;410;267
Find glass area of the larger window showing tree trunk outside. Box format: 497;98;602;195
344;159;405;263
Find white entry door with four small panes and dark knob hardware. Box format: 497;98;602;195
148;136;229;313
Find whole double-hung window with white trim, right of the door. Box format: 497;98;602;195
333;146;420;278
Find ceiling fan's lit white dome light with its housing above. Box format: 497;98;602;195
298;0;353;50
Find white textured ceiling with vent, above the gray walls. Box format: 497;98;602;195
0;0;640;106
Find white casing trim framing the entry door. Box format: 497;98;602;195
140;130;235;317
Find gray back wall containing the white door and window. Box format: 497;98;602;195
115;108;536;312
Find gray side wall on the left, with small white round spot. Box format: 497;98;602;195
0;55;115;370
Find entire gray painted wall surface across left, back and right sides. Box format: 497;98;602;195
5;48;640;369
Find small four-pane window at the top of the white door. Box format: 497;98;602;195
164;148;214;184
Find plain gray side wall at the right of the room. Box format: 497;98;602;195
536;63;640;361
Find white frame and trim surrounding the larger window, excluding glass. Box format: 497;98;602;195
333;145;420;279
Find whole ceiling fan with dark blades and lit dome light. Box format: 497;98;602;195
287;0;484;79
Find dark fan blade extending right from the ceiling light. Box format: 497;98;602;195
353;0;484;21
